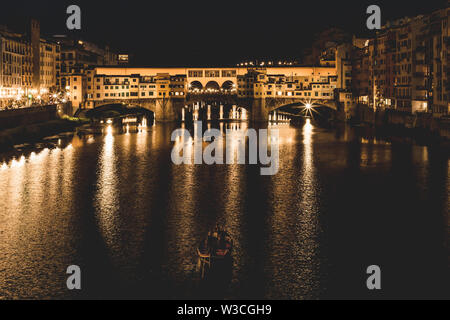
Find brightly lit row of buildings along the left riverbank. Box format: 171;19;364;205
0;19;119;109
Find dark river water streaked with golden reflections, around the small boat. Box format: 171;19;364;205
0;120;450;299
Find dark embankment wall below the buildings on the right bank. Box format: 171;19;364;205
355;105;450;140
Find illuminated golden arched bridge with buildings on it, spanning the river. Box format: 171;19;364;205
82;67;340;121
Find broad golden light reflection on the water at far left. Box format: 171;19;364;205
0;144;74;298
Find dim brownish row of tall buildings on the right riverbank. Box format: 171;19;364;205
352;8;450;117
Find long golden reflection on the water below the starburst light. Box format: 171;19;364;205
267;119;323;299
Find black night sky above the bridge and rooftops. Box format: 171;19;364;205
0;0;447;66
